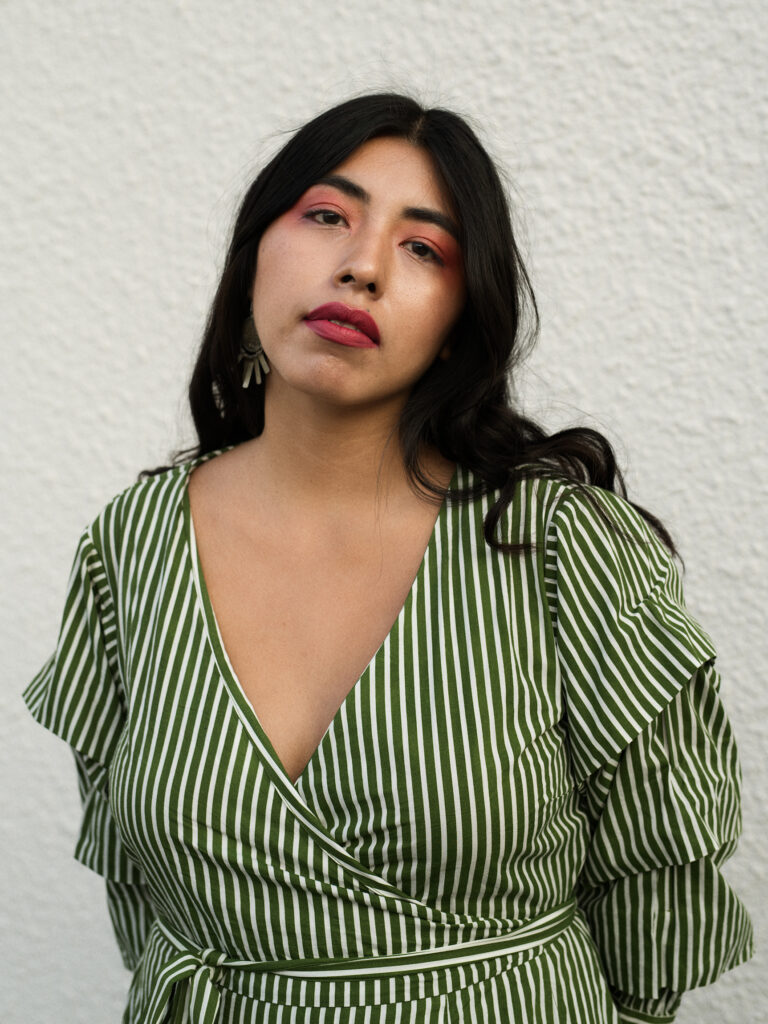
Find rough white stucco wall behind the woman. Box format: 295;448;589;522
0;0;768;1024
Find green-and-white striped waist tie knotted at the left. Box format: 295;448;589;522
141;900;575;1024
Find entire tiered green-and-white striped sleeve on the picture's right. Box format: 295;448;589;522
553;486;753;1024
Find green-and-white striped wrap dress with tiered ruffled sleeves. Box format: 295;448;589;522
24;449;753;1024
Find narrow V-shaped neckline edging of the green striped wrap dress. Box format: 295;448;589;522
181;444;459;793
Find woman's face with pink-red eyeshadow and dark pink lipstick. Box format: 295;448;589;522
252;138;466;414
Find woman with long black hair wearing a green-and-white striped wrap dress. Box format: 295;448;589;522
25;94;752;1024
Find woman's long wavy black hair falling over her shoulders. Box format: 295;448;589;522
141;92;678;555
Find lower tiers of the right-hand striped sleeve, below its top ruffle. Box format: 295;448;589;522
578;663;753;1024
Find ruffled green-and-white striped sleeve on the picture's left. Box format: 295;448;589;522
24;529;154;970
